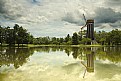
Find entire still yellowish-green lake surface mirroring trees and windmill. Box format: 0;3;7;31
0;47;121;81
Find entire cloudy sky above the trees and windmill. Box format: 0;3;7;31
0;0;121;37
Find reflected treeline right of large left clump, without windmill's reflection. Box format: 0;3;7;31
20;46;121;63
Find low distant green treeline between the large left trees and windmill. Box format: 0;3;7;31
33;32;91;45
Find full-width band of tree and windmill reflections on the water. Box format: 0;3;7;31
0;46;121;69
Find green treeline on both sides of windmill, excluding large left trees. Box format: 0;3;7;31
33;29;121;45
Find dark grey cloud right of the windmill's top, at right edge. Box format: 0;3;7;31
94;8;121;23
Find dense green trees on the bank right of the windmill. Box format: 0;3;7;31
95;29;121;45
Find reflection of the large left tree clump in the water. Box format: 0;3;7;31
0;48;34;68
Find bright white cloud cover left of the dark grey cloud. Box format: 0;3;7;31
0;0;121;36
